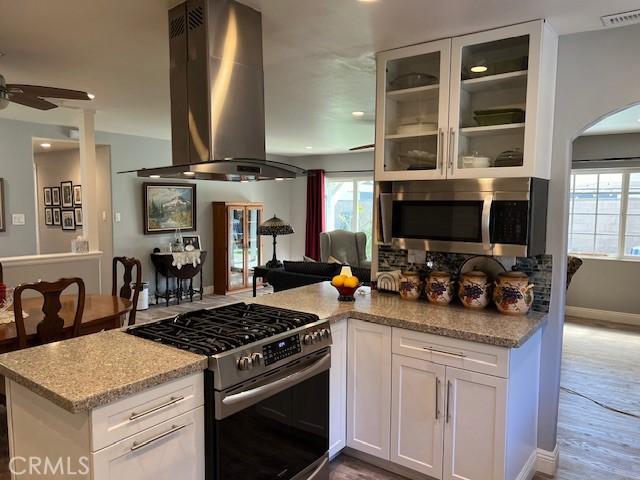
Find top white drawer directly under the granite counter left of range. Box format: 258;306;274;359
91;373;204;452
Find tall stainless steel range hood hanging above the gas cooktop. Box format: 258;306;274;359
137;0;306;181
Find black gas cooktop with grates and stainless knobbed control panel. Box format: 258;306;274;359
127;303;331;390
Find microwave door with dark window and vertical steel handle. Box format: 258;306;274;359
391;192;493;255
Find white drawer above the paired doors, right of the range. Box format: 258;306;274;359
392;328;509;378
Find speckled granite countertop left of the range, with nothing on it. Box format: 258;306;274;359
0;330;207;413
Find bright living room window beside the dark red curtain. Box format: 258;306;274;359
324;177;373;258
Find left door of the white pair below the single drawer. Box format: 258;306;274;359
391;355;445;478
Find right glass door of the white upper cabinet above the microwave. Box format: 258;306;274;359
449;24;540;178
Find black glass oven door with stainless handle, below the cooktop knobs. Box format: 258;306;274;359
208;349;331;480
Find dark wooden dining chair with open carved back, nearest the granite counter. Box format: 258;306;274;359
13;278;85;348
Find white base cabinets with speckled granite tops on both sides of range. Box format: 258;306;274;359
0;283;545;480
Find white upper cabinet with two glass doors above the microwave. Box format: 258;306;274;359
375;20;557;181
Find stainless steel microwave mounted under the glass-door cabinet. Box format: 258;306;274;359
380;178;549;256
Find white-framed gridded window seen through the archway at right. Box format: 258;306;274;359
569;169;640;259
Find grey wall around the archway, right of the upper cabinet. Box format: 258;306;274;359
538;21;640;450
